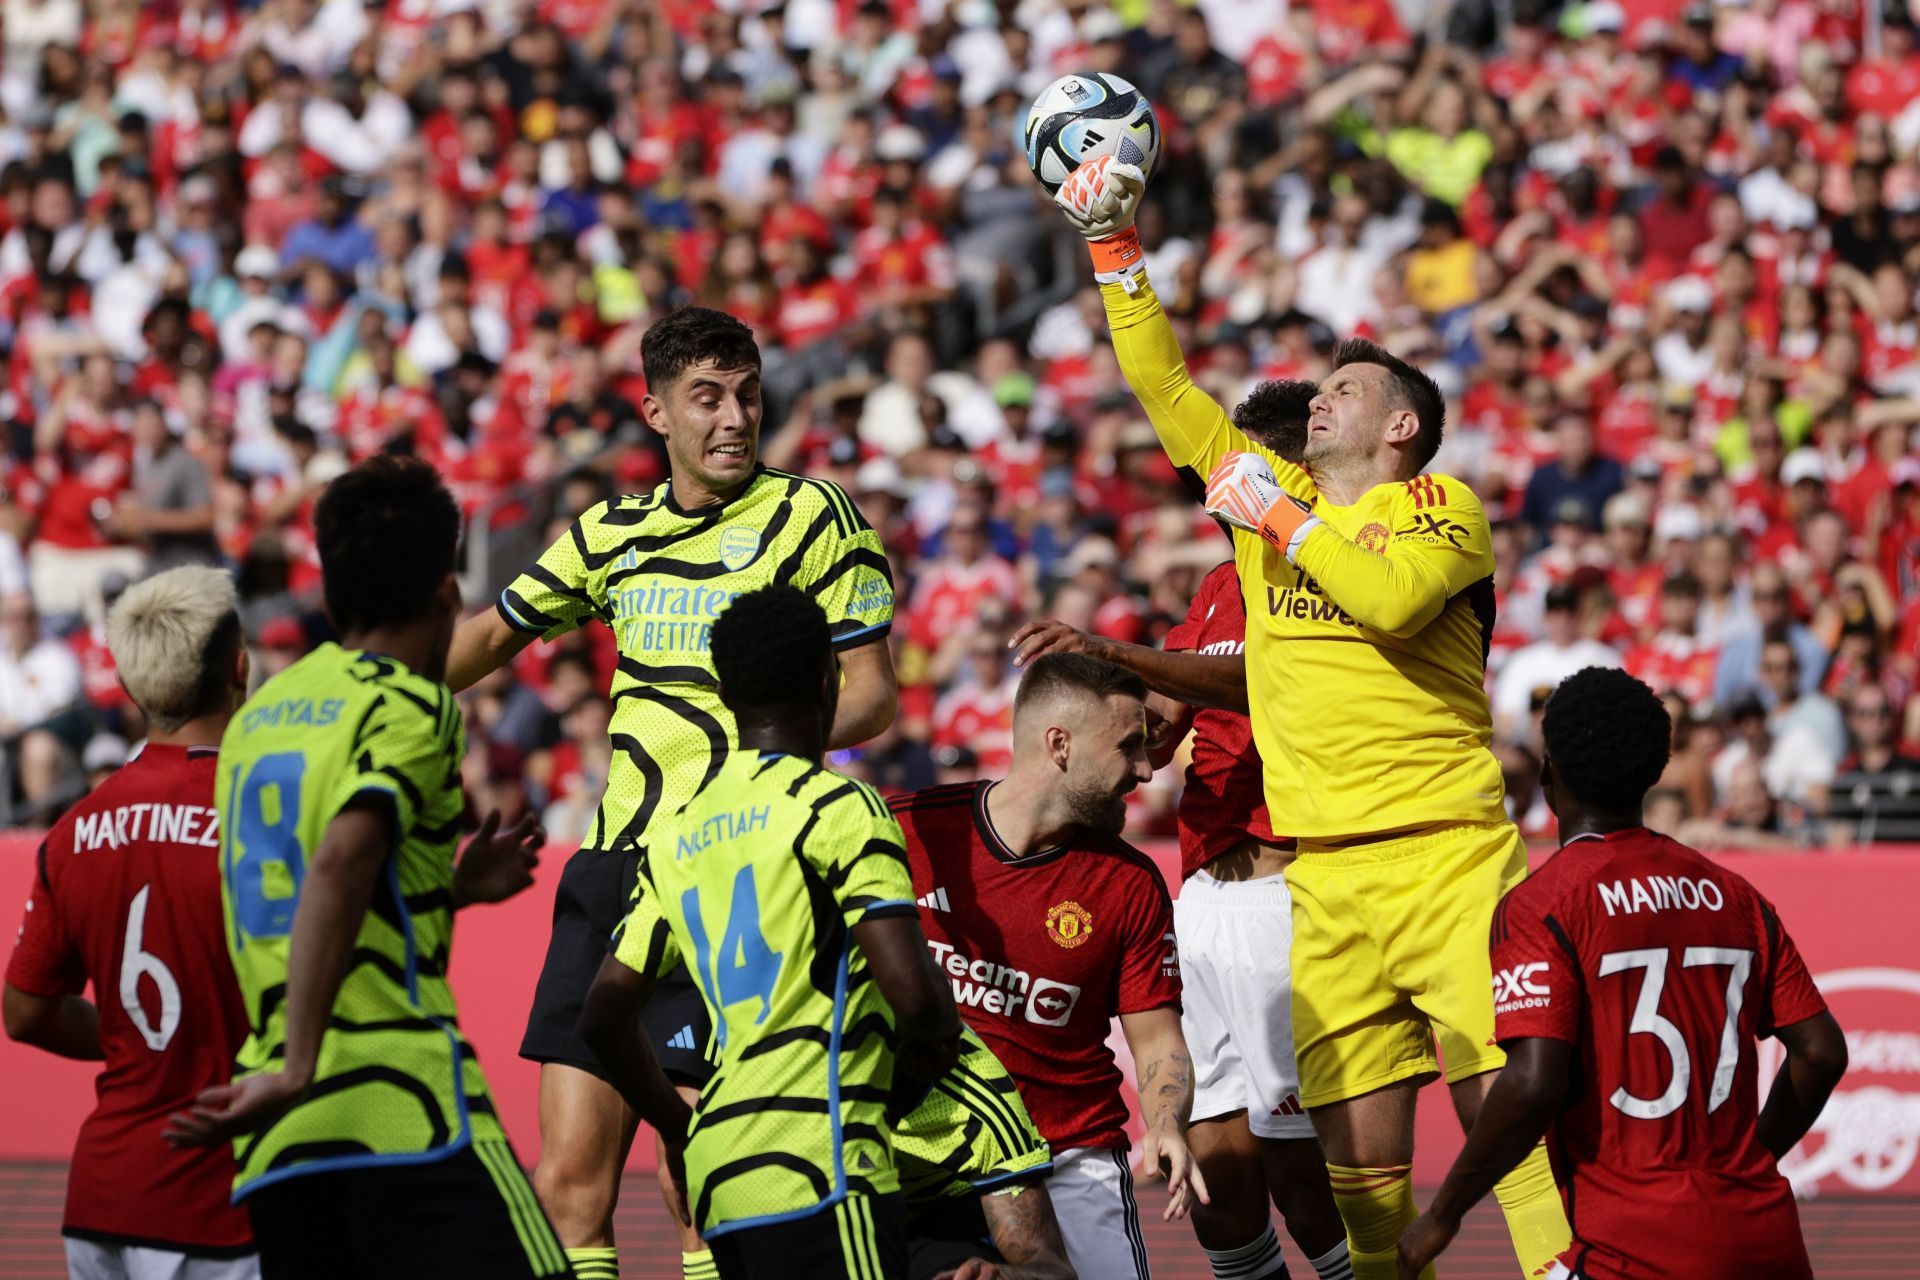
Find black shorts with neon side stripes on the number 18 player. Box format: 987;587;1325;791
242;1142;572;1280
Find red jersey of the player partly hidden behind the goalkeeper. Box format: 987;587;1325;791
1162;560;1279;879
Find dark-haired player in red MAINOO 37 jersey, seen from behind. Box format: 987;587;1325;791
1400;666;1847;1280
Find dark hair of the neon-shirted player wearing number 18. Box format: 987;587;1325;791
313;455;461;631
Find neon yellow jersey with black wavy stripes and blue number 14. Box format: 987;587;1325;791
614;750;918;1236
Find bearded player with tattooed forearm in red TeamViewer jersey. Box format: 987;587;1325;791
891;652;1208;1280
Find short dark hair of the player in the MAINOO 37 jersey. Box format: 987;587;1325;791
1540;666;1674;814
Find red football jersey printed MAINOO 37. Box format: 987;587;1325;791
1492;827;1826;1280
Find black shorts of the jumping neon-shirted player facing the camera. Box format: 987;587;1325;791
520;848;712;1088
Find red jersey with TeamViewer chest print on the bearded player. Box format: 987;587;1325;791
891;783;1181;1151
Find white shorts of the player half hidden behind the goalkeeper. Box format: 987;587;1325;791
1173;871;1313;1138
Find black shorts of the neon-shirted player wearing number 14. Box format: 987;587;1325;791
707;1194;906;1280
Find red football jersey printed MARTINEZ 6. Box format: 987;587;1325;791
6;745;253;1255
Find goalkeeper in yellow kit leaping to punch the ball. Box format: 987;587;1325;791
1054;157;1569;1280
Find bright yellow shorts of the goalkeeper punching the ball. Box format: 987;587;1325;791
1286;821;1526;1107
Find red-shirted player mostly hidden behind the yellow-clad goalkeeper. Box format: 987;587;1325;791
1012;380;1354;1280
